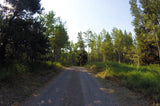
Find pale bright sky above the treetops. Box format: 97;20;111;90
41;0;134;42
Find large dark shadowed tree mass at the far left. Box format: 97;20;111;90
0;0;48;64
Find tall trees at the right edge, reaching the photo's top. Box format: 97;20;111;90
130;0;160;64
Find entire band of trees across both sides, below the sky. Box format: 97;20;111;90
0;0;160;69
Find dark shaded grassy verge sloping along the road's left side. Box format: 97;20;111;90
0;61;64;106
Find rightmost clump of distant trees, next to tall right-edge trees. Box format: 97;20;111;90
112;28;134;63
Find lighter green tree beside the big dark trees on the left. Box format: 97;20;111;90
39;11;69;62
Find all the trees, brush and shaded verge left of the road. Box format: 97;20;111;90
0;0;69;106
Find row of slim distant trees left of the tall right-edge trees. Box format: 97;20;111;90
68;28;133;63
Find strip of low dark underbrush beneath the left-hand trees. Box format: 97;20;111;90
0;61;63;83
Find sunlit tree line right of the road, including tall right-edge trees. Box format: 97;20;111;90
69;0;160;65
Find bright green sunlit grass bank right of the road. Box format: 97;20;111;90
86;62;160;103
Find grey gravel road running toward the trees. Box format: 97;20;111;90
23;67;119;106
